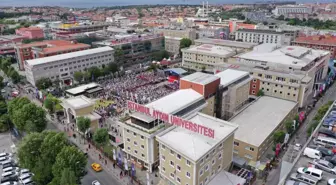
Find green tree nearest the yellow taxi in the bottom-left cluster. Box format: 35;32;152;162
52;146;87;179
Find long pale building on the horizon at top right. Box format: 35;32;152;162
273;5;313;16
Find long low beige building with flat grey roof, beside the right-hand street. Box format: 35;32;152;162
230;96;298;161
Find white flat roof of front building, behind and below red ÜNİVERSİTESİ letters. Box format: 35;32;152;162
157;113;238;161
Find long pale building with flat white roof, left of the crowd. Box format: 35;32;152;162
25;47;114;86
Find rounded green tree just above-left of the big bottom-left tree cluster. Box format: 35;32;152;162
12;103;47;132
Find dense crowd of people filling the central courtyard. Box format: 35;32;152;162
96;71;178;116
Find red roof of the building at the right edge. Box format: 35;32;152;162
294;35;336;46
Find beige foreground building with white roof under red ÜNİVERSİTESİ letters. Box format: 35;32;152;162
156;113;238;185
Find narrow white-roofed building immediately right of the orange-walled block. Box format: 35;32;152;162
215;69;252;120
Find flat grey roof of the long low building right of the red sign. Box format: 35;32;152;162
230;96;297;147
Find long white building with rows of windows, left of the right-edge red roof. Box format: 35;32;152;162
235;29;292;45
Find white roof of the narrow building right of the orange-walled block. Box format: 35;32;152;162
215;69;249;86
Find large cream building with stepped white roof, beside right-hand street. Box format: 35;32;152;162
217;44;330;107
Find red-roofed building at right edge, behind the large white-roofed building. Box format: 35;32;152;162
292;35;336;59
